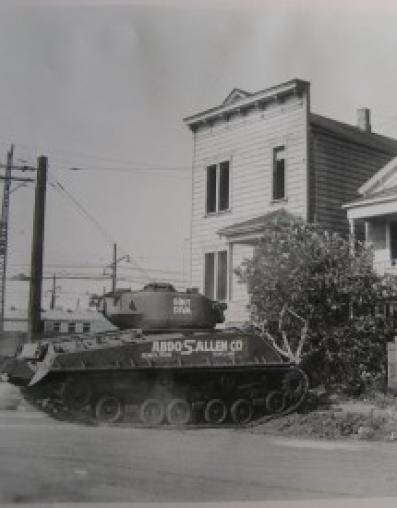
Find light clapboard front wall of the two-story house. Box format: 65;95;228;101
191;91;308;320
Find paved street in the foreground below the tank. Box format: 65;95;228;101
0;410;397;503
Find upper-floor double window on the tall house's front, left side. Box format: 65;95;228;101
206;161;230;214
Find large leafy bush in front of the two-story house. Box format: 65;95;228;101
237;220;390;392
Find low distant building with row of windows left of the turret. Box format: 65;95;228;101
41;310;116;336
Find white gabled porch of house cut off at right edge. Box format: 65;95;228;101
343;157;397;275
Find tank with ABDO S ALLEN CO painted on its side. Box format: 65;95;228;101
1;284;308;425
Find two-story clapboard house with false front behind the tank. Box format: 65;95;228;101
184;79;397;321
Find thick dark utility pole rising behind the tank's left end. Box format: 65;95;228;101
28;156;47;341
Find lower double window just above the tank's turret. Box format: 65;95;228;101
204;250;227;300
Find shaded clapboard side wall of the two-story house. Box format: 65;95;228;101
309;125;393;235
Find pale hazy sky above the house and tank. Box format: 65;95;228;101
0;0;397;308
